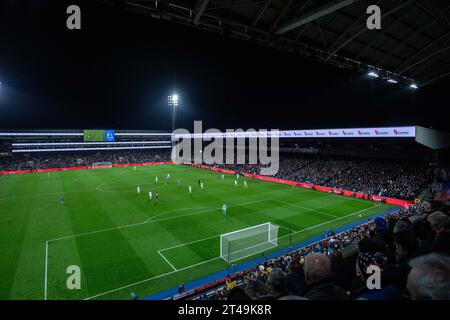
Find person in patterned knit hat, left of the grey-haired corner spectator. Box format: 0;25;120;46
354;252;401;300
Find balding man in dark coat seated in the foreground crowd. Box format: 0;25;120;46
305;253;349;300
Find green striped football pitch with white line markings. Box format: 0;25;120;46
0;165;392;299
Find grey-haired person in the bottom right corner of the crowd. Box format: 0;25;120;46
407;253;450;300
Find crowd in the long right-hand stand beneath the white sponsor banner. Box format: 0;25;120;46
217;157;432;200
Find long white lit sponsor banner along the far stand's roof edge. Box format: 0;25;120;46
171;127;416;139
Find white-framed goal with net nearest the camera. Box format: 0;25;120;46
220;222;278;262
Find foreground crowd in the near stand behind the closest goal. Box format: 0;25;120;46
199;202;450;300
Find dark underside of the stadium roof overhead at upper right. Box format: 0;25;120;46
98;0;450;86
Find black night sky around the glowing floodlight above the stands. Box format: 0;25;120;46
0;0;449;130
